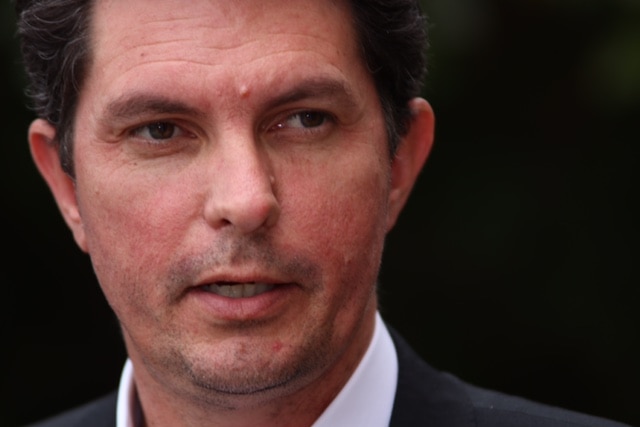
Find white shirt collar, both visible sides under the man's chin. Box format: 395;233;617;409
116;313;398;427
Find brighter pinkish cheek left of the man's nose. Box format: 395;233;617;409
78;167;195;300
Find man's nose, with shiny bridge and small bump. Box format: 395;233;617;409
204;138;280;234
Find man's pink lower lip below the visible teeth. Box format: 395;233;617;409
189;284;298;322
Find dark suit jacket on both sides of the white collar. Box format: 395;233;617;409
27;331;624;427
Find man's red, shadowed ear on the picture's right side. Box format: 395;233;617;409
387;98;435;231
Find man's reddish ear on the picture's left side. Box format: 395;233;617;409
29;119;87;252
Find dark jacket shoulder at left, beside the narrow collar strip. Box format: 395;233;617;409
28;392;117;427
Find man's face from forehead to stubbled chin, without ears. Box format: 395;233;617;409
57;0;398;408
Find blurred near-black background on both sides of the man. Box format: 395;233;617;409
0;0;640;427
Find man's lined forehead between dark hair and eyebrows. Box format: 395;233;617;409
91;0;361;93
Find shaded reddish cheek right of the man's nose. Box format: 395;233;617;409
281;155;388;280
